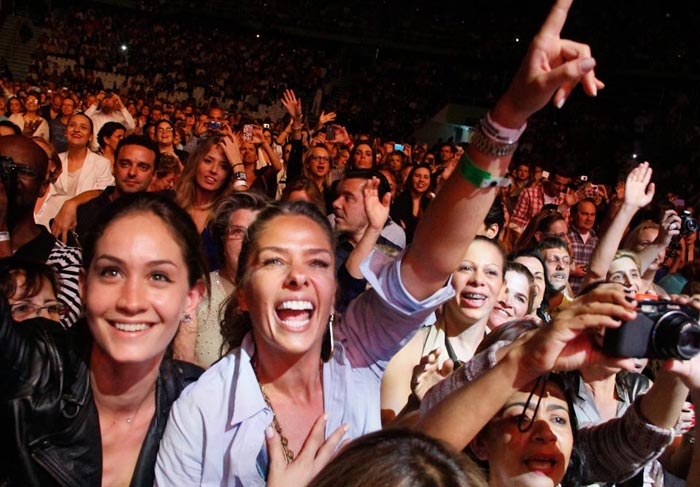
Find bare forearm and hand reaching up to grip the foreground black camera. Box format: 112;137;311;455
418;284;636;450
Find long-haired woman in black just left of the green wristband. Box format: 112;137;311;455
391;164;430;243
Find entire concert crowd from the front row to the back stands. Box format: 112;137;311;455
0;0;700;487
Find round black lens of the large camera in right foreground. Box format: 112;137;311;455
651;311;700;360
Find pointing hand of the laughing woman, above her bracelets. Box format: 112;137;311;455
492;0;605;128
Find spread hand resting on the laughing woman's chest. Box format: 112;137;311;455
265;414;348;487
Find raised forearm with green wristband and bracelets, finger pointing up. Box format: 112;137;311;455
401;0;603;299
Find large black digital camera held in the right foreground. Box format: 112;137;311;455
603;296;700;360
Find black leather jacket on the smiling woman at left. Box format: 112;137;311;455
0;295;202;487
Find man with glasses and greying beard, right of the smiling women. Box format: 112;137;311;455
536;237;573;314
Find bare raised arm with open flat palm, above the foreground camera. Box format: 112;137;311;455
583;162;654;286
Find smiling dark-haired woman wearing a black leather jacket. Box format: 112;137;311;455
0;193;205;485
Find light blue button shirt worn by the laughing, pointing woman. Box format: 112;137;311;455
156;252;454;486
